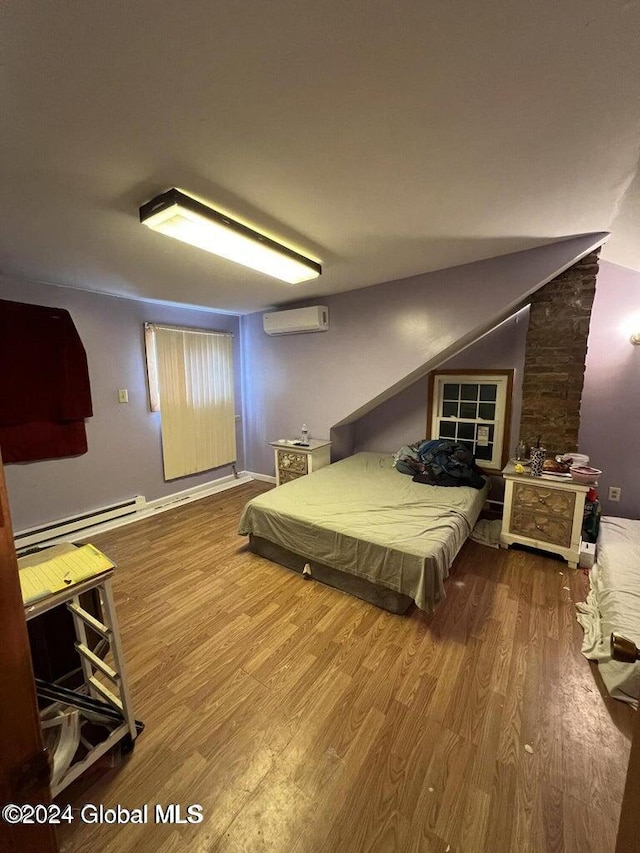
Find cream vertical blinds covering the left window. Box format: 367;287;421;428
145;324;236;480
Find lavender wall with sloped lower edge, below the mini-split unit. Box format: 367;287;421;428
241;235;604;474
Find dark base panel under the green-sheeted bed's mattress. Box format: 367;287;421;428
249;534;413;614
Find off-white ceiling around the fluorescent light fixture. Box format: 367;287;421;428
0;0;640;312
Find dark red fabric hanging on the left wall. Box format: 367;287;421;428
0;299;93;463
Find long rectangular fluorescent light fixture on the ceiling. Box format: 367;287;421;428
140;189;322;284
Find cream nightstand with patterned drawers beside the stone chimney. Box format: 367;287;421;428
500;462;592;569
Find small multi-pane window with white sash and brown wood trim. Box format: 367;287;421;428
427;370;513;471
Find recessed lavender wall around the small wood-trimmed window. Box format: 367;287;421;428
353;308;529;460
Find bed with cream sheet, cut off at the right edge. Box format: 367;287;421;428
576;516;640;705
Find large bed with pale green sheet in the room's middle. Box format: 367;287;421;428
238;453;489;613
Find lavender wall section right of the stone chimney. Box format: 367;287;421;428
579;261;640;518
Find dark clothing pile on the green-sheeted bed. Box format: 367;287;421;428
393;438;485;489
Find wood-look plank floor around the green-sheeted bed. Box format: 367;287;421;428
58;483;631;853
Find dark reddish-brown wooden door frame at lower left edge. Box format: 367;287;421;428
0;455;58;853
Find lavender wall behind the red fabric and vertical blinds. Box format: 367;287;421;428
0;277;244;531
